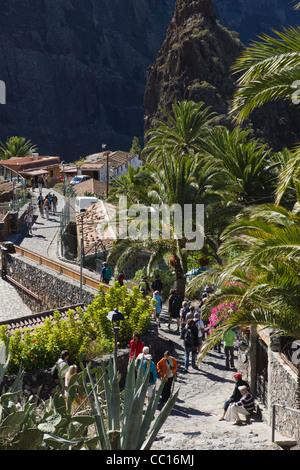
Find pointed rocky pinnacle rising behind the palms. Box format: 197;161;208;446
144;0;243;138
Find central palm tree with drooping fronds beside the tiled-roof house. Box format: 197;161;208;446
109;153;222;298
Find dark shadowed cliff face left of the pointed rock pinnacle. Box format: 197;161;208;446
0;0;174;160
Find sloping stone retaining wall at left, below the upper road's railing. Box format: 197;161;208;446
7;254;97;312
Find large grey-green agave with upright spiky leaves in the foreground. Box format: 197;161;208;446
83;359;179;450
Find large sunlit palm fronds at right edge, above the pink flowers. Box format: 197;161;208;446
197;204;300;354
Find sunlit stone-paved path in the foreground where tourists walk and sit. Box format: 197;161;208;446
152;306;286;451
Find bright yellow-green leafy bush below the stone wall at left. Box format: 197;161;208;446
0;283;153;373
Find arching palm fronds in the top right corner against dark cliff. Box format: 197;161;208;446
231;27;300;122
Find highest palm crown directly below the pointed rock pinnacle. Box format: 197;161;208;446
143;101;214;161
